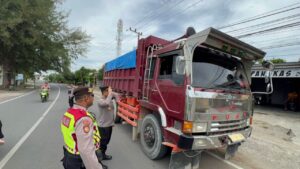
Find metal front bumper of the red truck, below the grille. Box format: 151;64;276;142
177;127;252;150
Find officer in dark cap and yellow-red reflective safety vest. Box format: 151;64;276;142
61;87;106;169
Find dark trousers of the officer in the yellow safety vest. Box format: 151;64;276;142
62;148;85;169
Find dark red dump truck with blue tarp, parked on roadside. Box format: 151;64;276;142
103;28;271;169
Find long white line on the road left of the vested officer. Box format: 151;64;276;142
0;87;60;168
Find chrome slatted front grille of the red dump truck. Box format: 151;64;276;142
209;119;247;133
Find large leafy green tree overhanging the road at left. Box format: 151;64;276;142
0;0;90;87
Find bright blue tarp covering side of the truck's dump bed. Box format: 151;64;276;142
104;50;136;72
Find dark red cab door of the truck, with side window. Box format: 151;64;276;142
150;50;185;116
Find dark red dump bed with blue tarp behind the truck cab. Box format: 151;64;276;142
103;36;170;98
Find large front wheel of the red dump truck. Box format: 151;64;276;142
140;114;168;160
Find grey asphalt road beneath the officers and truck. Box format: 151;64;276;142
0;85;239;169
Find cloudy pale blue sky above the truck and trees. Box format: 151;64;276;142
59;0;300;70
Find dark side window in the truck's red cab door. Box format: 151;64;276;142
158;54;184;85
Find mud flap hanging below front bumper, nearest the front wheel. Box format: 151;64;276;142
169;151;202;169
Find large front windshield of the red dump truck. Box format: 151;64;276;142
192;47;249;90
